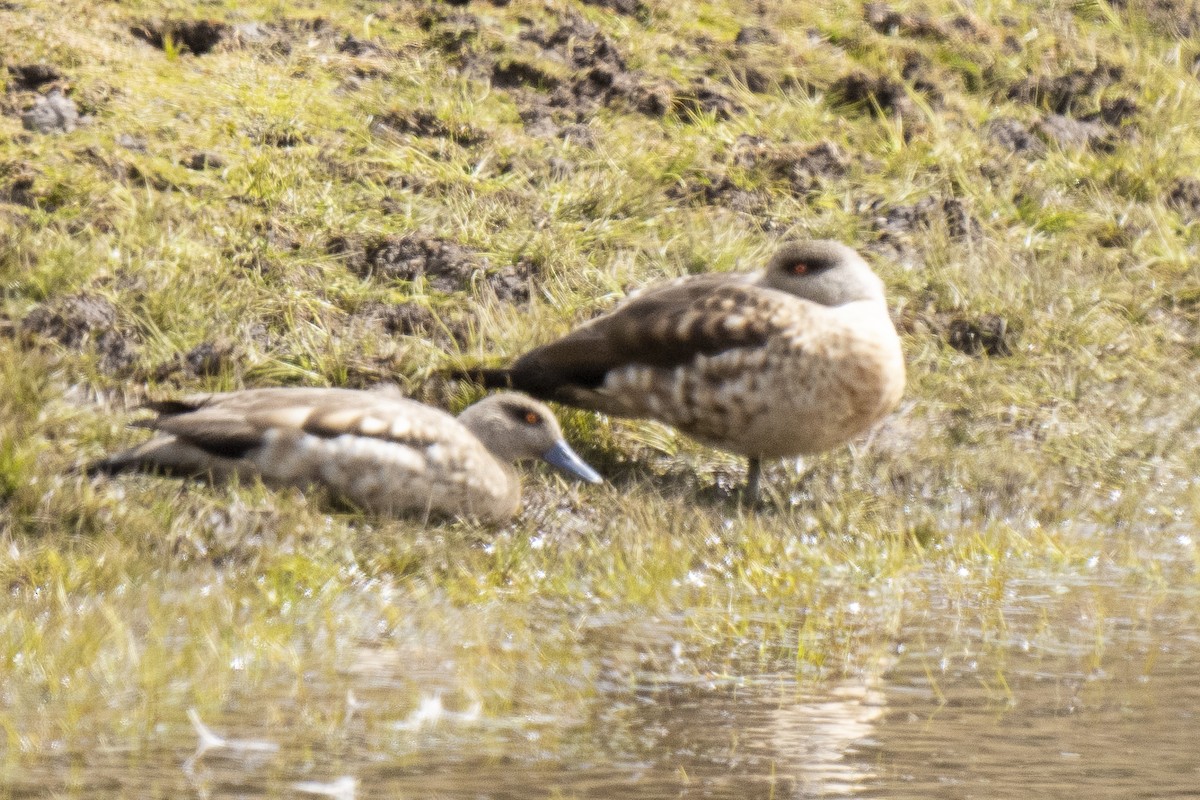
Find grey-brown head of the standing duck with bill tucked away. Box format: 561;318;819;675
763;239;883;306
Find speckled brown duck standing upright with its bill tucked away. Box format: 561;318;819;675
466;241;905;498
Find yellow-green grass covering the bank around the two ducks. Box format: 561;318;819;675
0;0;1200;796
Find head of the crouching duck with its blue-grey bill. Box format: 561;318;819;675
458;392;602;483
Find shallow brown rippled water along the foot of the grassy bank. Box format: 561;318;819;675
0;568;1200;800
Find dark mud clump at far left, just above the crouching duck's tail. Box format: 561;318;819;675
20;293;138;374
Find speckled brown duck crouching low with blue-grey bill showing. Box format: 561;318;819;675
88;389;600;523
